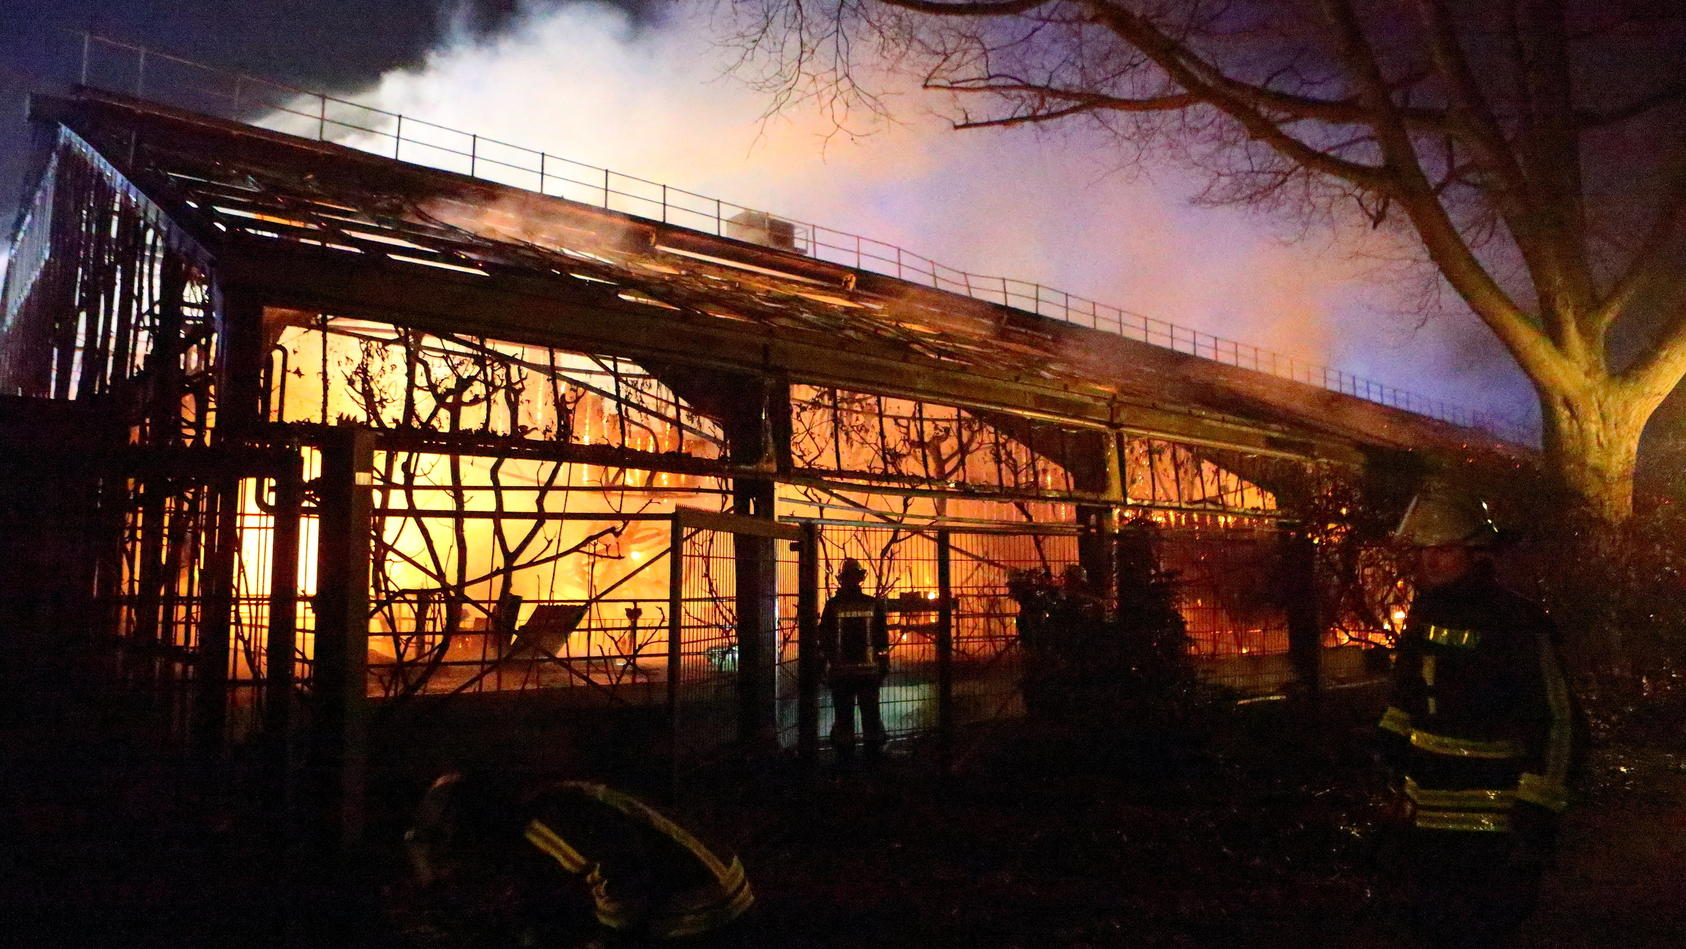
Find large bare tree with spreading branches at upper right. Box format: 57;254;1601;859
730;0;1686;523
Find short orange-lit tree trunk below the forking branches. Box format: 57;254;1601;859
1539;384;1656;524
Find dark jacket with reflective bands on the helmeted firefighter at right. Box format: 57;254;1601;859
1381;568;1578;831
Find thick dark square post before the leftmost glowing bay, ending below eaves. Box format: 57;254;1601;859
312;426;374;846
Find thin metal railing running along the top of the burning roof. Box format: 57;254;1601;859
78;34;1536;445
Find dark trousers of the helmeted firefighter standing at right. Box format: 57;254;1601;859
1383;828;1544;949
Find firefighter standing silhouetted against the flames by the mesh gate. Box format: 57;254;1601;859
819;558;890;765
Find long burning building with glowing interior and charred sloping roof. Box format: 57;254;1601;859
0;40;1526;836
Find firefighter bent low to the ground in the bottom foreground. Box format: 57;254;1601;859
405;772;755;946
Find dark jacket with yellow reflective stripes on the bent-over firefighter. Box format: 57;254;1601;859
523;782;755;939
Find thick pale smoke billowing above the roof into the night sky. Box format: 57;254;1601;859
322;2;1529;431
